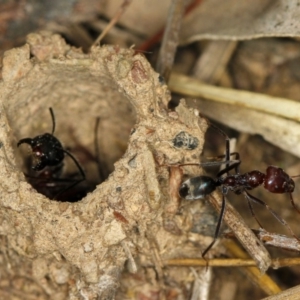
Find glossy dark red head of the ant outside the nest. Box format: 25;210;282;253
264;166;295;194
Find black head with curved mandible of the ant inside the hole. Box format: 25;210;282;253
17;133;64;171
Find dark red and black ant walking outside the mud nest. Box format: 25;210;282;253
179;129;300;258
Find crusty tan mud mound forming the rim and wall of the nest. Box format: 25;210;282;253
0;32;207;299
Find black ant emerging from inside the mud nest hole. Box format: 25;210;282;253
17;107;85;198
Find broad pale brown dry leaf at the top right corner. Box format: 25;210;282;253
181;0;300;44
